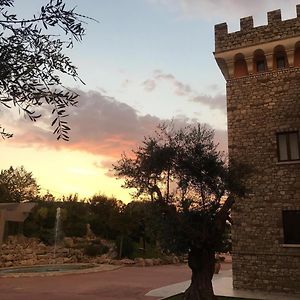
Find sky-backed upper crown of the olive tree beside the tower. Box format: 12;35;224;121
114;124;241;205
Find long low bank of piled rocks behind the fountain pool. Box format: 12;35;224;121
0;236;180;268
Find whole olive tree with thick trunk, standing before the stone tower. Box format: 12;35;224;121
114;124;245;300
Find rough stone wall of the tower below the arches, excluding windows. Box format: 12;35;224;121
227;67;300;293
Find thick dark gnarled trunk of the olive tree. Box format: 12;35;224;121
184;248;217;300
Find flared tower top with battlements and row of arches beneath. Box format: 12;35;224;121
214;4;300;80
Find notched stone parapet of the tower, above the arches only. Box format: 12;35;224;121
215;4;300;53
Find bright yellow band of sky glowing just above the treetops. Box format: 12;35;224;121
0;144;131;203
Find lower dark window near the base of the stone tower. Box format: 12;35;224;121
282;210;300;244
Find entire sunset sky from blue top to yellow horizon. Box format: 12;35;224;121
0;0;300;202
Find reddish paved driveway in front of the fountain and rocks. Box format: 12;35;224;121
0;265;191;300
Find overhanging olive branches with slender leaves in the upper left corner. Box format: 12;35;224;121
0;0;92;140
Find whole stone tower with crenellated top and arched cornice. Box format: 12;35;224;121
215;5;300;293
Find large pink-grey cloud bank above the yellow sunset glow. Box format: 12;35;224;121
7;91;227;161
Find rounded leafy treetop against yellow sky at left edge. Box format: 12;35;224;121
0;166;39;202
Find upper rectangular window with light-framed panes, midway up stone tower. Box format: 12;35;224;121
277;131;300;161
